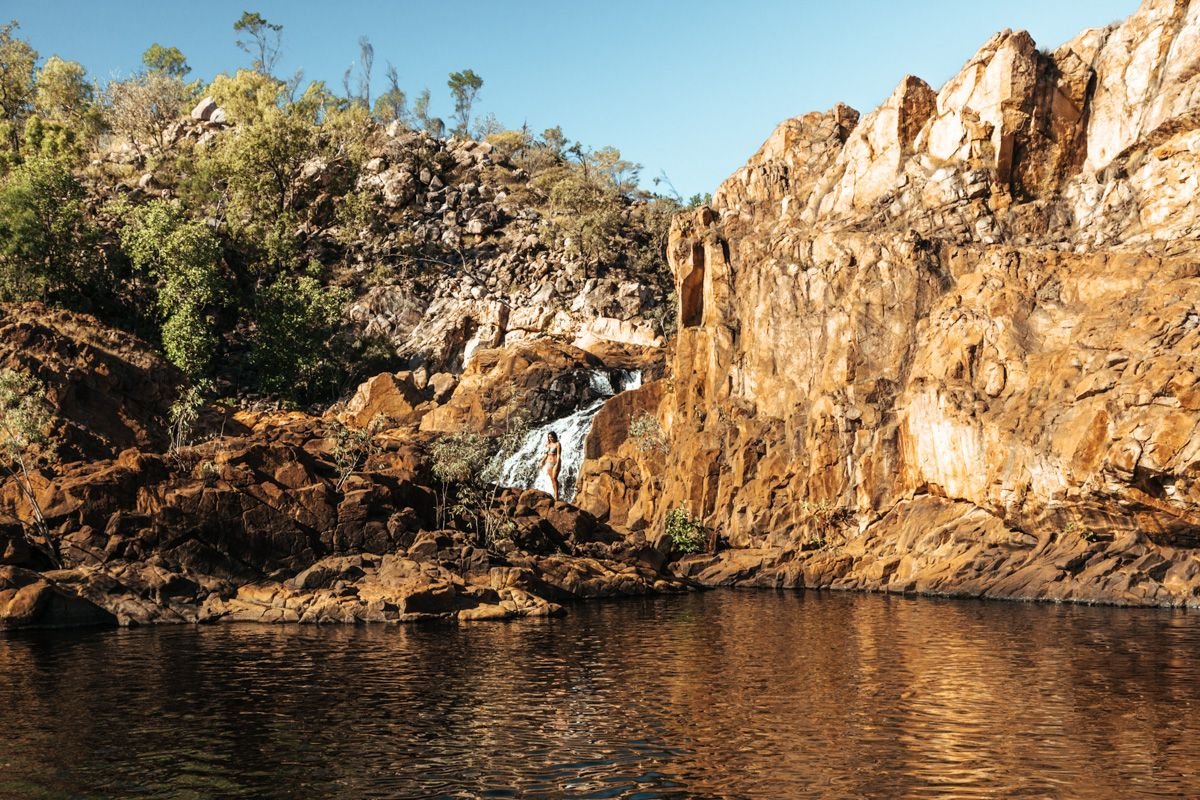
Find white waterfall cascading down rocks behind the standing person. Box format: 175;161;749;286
496;369;642;500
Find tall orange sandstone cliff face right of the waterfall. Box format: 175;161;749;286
580;0;1200;604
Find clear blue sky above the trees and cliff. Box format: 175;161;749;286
7;0;1136;196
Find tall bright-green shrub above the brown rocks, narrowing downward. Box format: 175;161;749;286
121;200;223;380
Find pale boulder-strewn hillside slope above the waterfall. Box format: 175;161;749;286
346;126;666;373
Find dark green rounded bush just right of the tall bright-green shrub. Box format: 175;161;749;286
250;268;350;403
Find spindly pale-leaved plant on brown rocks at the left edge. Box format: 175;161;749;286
0;369;61;565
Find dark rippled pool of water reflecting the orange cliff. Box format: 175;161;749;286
0;591;1200;799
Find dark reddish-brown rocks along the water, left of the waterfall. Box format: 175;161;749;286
0;303;686;631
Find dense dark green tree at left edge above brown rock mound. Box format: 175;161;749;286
0;158;97;301
